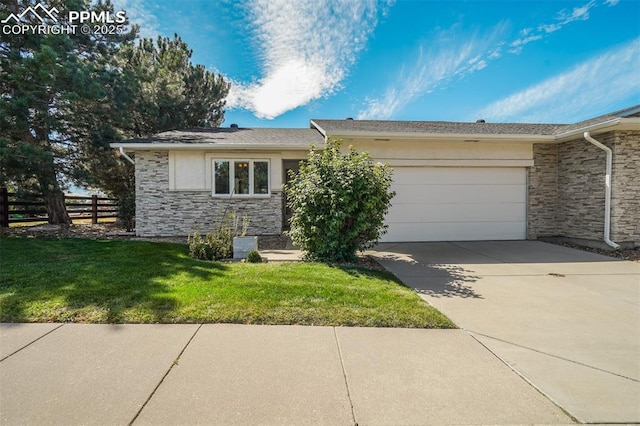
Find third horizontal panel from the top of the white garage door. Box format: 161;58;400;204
387;203;525;224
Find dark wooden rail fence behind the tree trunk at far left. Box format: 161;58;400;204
0;188;118;228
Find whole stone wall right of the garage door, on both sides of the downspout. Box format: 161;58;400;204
527;131;640;243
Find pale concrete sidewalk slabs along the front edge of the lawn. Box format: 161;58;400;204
0;324;571;425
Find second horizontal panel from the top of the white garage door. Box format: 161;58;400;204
391;185;527;205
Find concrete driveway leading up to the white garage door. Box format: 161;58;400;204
373;241;640;423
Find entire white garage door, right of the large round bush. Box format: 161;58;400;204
382;167;527;241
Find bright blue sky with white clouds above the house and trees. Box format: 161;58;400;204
114;0;640;127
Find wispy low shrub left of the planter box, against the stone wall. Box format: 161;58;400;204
187;212;249;260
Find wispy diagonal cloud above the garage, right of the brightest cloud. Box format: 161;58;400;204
357;23;506;120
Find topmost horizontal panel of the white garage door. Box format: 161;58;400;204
393;167;527;185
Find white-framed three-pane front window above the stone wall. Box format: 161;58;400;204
213;160;269;195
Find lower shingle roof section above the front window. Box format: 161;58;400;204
121;127;324;148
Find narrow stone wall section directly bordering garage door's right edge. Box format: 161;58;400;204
527;144;559;240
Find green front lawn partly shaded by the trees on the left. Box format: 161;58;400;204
0;238;455;328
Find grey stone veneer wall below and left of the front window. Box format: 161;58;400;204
136;151;282;237
